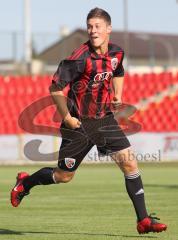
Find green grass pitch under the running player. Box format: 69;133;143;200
0;163;178;240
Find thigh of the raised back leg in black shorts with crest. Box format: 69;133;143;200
58;124;93;172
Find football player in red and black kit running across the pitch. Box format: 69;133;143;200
11;8;167;233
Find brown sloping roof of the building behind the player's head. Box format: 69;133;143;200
37;29;178;64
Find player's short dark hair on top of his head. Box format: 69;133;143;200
87;7;111;25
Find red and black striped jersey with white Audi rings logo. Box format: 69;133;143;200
53;41;124;118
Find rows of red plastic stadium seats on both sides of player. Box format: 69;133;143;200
0;72;178;134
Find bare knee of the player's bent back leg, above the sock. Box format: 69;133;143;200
54;170;75;183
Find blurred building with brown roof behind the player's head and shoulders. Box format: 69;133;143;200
37;29;178;73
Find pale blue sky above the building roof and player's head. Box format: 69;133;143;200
0;0;178;58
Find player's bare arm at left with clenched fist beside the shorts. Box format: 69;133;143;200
49;84;81;129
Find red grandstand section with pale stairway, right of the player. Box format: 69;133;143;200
124;72;178;132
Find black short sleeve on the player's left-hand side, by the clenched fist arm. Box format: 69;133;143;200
53;60;85;90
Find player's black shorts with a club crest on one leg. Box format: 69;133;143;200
58;114;130;172
